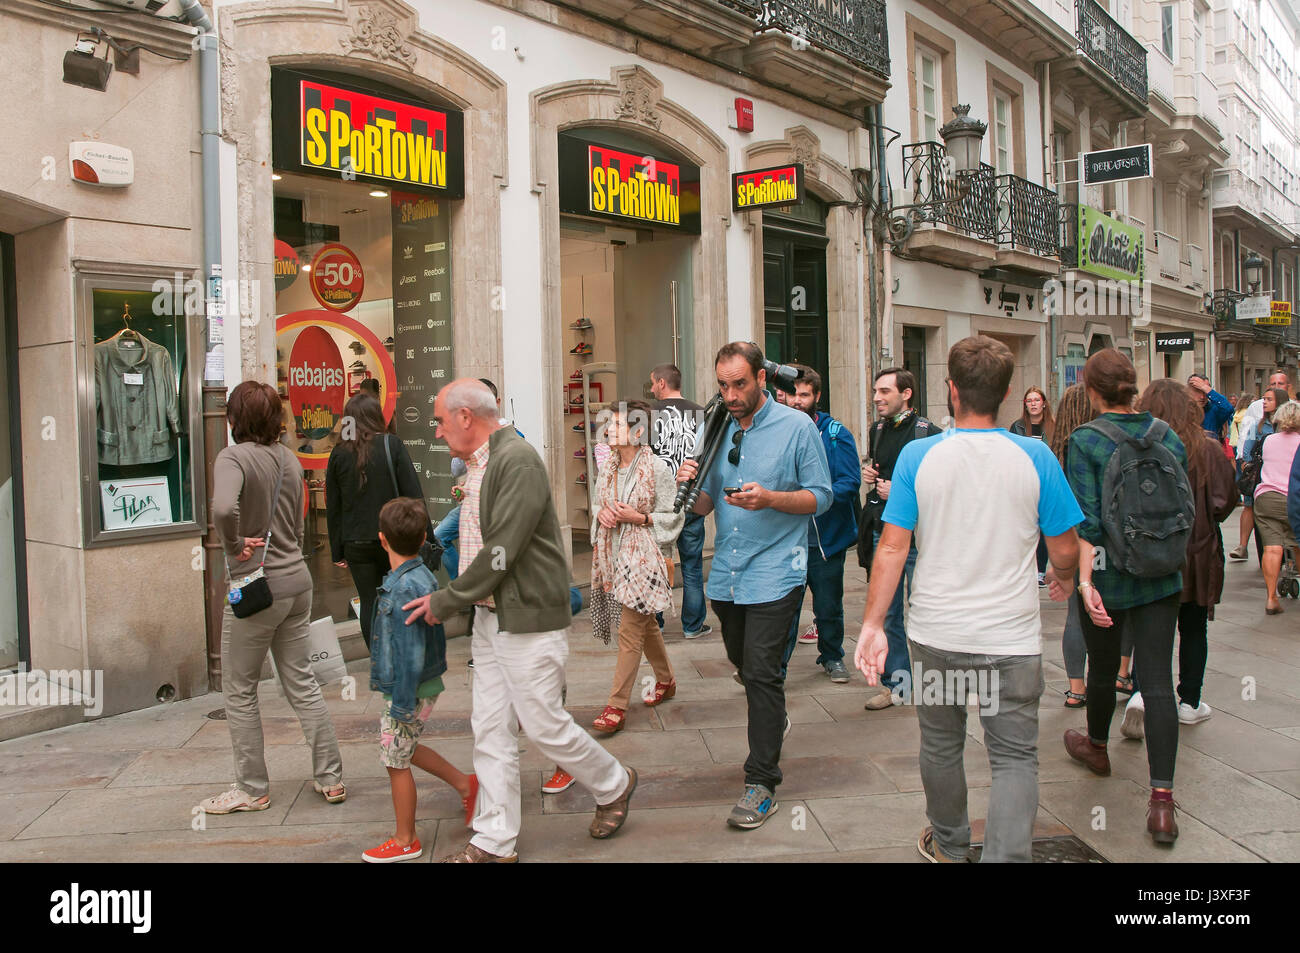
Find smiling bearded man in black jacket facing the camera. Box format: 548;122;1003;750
862;368;940;711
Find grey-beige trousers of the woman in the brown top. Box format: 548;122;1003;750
221;589;343;797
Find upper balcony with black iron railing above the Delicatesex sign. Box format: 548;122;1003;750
1053;0;1147;121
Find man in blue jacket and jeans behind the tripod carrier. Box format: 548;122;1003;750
784;364;862;684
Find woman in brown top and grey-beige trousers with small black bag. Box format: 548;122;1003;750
202;381;347;814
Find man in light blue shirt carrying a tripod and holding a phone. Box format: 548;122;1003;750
677;341;831;831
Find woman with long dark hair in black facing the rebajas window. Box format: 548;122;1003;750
325;391;433;650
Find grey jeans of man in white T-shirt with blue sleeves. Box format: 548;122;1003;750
910;641;1043;863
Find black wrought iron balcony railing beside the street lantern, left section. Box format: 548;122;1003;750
902;142;997;242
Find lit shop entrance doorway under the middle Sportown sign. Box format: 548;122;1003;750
560;216;703;572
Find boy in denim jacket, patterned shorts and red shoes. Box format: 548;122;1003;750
361;497;478;863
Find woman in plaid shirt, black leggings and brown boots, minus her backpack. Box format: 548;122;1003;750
1065;347;1187;844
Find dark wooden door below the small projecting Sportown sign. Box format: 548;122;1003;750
763;195;831;411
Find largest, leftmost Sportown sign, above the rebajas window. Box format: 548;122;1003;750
272;70;464;198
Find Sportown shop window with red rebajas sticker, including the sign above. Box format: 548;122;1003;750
268;69;464;621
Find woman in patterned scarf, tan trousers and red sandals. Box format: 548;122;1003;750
592;400;685;735
